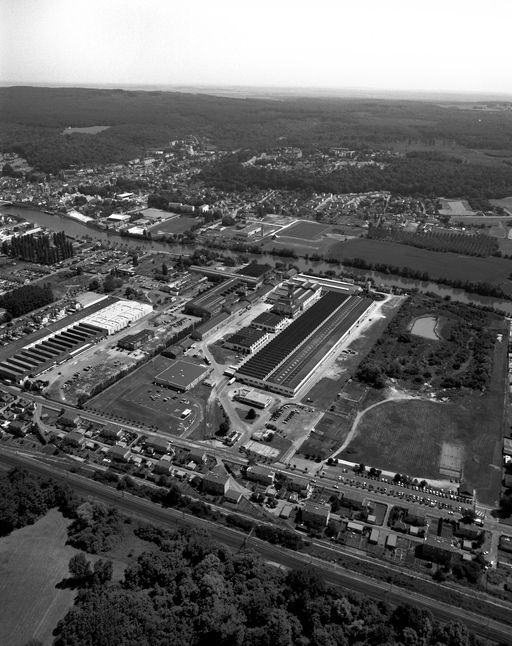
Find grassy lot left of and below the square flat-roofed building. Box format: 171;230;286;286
86;355;202;434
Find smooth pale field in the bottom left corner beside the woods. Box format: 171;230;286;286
0;510;77;646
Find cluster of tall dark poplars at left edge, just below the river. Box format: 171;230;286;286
2;231;74;265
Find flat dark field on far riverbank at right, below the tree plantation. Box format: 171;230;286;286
330;238;512;294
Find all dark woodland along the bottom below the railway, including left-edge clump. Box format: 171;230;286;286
0;468;510;646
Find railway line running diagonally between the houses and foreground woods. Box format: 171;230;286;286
0;453;512;643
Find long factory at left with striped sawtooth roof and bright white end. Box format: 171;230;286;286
0;297;153;383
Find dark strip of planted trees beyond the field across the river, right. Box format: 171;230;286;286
368;223;499;258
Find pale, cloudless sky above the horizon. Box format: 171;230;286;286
0;0;512;95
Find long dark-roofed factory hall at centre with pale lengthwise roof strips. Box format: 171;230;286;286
235;291;374;397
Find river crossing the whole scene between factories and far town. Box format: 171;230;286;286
4;205;512;316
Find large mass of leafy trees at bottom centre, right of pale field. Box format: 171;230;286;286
56;527;488;646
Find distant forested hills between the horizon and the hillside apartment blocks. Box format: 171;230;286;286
0;87;512;178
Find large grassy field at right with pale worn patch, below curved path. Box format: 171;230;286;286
340;360;505;505
